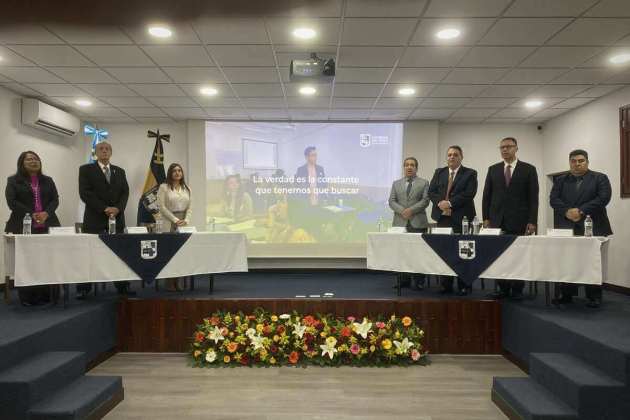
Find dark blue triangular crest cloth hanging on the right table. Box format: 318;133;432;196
422;234;517;286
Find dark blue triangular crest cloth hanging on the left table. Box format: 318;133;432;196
99;233;191;282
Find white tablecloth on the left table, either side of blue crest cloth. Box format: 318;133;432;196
5;232;252;287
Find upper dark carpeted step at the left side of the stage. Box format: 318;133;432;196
0;351;86;419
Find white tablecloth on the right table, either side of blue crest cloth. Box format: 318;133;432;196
367;233;608;284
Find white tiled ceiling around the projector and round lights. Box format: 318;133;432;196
0;0;630;123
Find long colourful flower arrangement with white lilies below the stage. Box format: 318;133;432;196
190;309;426;367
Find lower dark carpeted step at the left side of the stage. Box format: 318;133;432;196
28;376;123;420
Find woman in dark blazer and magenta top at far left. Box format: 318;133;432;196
4;150;60;305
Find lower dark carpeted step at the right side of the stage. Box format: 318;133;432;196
492;378;578;420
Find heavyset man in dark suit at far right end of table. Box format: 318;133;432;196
549;149;612;308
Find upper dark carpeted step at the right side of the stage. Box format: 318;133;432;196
529;353;630;419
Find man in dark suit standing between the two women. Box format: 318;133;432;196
77;142;129;298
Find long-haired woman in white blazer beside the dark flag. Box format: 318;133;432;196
158;163;191;291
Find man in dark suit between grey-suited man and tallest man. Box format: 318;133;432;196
429;146;477;295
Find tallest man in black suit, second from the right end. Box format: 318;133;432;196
482;137;538;300
